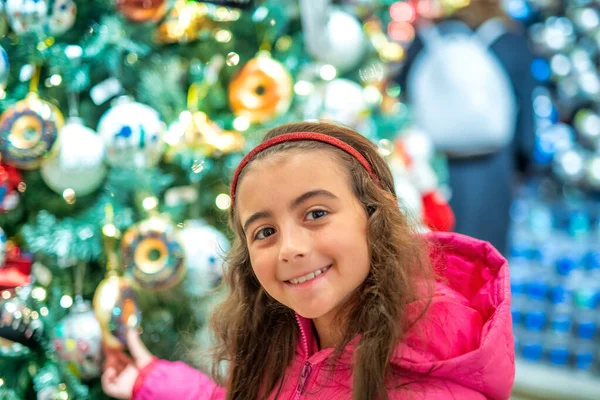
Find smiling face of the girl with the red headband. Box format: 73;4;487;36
236;150;370;320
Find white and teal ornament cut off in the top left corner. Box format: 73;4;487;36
5;0;48;35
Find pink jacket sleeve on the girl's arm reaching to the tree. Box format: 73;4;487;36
132;360;225;400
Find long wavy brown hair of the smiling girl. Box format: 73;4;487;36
212;123;433;400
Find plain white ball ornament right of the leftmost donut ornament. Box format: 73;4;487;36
41;118;106;196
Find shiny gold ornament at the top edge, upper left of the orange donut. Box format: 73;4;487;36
156;0;218;44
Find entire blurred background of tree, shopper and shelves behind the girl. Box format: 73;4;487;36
0;0;600;400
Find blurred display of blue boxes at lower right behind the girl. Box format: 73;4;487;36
508;184;600;380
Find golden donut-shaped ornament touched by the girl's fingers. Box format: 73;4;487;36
93;271;141;349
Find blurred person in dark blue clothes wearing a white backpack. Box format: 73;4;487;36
398;0;535;254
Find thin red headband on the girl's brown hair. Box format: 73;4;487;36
231;132;379;207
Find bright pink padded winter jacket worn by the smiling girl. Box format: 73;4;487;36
133;233;515;400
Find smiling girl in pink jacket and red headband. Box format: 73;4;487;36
102;123;514;400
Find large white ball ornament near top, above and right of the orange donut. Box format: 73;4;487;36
313;10;367;72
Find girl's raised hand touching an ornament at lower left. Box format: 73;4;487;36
102;329;154;399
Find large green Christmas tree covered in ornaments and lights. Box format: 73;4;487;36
0;0;451;399
